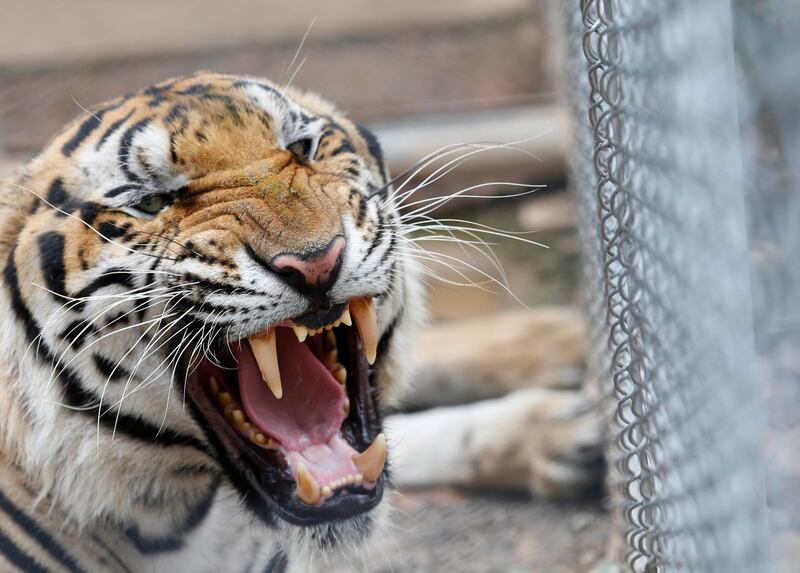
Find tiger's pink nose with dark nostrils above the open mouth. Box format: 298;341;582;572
269;235;346;298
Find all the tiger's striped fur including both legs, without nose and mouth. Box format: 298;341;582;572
0;73;600;573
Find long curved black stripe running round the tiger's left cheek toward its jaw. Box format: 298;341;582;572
4;245;208;453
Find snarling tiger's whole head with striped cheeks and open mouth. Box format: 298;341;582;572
4;74;419;544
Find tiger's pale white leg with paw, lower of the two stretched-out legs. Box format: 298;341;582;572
386;388;602;499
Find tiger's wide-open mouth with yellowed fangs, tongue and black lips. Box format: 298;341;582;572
187;297;386;525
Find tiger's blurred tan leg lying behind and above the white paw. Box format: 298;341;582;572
402;307;586;409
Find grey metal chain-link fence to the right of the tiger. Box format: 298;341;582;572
562;0;800;573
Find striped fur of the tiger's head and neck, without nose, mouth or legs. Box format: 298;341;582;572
0;73;419;571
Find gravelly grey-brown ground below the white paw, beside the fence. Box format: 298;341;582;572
340;489;610;573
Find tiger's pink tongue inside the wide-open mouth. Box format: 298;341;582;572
235;328;349;454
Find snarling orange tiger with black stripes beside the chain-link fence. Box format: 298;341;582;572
0;72;596;573
